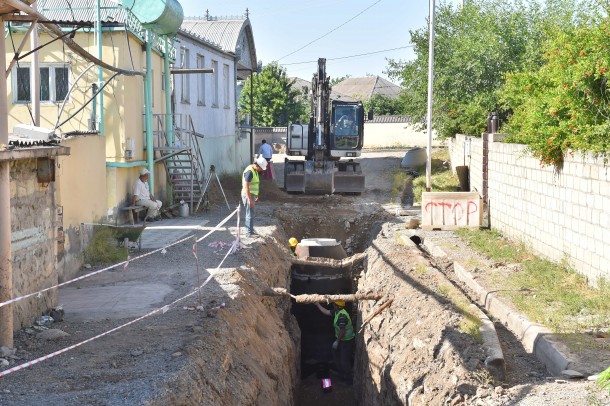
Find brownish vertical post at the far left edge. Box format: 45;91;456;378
0;16;13;348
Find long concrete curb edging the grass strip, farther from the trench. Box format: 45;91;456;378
424;241;573;376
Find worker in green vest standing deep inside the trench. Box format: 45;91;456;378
316;301;356;385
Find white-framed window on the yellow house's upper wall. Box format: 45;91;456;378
13;65;70;103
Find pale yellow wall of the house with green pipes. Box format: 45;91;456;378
6;31;167;216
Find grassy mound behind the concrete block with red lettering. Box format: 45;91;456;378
413;148;460;203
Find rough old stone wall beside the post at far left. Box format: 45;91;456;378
10;159;58;330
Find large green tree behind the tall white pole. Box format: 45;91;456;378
387;0;588;137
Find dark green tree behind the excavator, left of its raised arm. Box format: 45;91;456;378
239;62;306;126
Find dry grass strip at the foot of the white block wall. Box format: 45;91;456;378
457;229;610;333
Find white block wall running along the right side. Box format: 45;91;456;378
450;135;610;282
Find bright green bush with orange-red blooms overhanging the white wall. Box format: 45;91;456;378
502;8;610;167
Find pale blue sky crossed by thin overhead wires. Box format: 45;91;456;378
178;0;461;80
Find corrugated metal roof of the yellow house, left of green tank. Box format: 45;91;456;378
38;0;125;24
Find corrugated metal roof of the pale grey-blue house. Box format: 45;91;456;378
180;17;245;52
